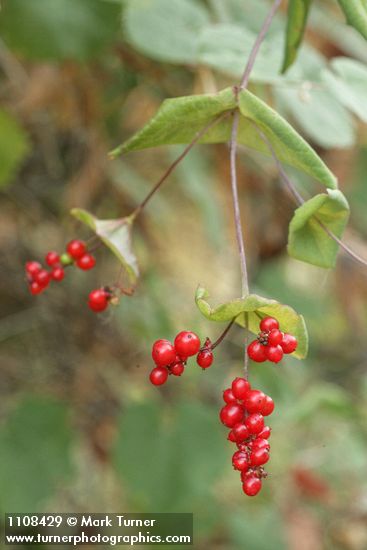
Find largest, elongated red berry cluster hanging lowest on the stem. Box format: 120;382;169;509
220;378;274;496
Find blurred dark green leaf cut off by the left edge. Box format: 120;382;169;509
0;110;30;187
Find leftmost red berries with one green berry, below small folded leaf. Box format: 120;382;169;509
25;239;115;313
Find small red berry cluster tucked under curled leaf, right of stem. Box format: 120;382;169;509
247;317;297;363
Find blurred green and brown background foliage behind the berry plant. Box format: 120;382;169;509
0;0;367;550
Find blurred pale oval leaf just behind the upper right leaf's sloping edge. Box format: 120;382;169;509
275;83;356;149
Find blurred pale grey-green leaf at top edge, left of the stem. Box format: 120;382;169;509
123;0;209;63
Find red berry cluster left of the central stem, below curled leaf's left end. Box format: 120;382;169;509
150;330;213;386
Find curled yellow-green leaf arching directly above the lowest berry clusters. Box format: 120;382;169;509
195;286;308;359
